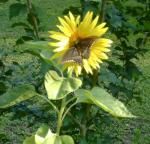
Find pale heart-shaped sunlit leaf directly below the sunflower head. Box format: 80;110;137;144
45;71;82;100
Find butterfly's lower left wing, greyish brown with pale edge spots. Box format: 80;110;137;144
62;46;82;64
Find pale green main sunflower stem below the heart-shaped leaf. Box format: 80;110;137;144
56;98;66;135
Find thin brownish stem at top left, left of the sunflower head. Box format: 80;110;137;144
27;0;39;40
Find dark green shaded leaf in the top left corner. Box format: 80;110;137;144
9;3;27;19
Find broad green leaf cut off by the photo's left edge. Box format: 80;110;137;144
0;84;36;108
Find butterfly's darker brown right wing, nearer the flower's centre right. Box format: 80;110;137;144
78;37;96;59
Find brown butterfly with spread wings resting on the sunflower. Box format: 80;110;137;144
62;37;96;65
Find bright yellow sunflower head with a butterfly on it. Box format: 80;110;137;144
49;11;112;76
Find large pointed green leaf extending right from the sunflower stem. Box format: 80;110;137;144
75;87;135;117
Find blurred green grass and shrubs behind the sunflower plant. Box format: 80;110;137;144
0;0;150;144
